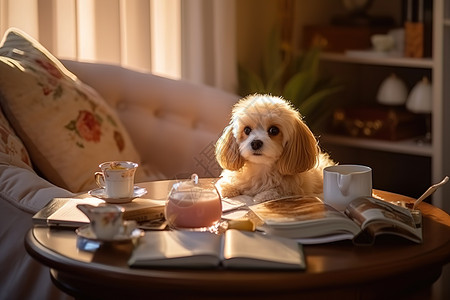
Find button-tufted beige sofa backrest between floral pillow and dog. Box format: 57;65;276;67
62;60;239;179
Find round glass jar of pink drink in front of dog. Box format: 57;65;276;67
165;190;222;228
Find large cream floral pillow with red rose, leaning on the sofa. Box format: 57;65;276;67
0;29;140;192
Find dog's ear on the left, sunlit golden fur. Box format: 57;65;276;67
216;124;244;171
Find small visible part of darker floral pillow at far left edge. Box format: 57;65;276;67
0;106;32;169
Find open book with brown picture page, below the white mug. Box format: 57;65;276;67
250;196;422;244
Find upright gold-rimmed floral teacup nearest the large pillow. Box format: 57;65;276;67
95;161;138;199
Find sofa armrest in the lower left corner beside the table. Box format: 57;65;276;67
0;164;74;299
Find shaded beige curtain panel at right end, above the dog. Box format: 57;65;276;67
181;0;237;91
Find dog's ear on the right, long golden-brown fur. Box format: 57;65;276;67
278;118;319;175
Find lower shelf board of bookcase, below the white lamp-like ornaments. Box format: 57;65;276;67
320;134;433;157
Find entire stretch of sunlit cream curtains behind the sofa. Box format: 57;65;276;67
0;0;237;92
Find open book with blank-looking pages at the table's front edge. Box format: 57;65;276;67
128;229;305;270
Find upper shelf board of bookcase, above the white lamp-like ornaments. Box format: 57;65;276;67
321;51;433;69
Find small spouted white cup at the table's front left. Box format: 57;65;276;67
77;204;125;240
